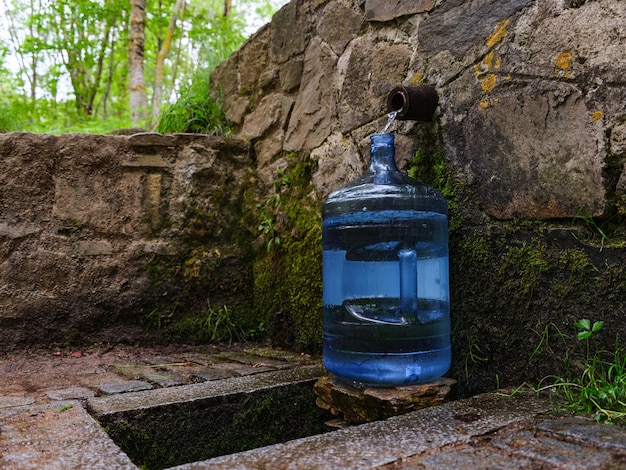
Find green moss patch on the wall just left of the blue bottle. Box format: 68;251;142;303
249;155;322;352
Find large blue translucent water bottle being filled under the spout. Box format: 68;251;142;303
322;134;450;386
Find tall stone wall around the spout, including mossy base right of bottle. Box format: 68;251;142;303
211;0;626;393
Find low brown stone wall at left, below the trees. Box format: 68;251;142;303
0;133;251;351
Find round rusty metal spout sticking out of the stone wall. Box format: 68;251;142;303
387;85;439;121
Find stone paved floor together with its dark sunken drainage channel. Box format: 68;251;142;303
0;351;626;469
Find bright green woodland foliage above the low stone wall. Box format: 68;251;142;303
0;0;279;134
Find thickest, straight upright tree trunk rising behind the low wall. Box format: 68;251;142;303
128;0;148;126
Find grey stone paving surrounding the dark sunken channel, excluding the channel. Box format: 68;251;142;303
0;347;626;469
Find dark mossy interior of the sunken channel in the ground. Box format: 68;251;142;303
100;380;331;469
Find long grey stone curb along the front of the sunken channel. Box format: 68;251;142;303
176;393;553;470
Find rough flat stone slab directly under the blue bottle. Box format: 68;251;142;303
315;375;457;427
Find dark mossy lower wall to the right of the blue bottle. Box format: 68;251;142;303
450;221;626;395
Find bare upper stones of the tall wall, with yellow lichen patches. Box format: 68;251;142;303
212;0;626;219
